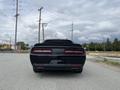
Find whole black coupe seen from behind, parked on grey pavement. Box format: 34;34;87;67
30;39;86;73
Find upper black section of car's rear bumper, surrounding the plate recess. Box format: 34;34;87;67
30;55;86;65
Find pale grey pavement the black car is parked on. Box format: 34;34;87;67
0;53;120;90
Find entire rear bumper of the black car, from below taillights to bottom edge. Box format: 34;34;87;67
30;55;86;70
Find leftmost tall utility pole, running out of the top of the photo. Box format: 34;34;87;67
15;0;19;50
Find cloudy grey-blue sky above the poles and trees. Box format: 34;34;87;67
0;0;120;45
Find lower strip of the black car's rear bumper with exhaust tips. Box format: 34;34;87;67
33;64;83;70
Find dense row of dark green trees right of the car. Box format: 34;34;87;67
83;38;120;51
